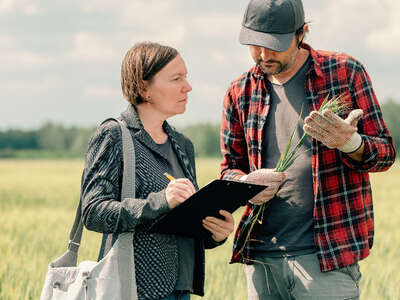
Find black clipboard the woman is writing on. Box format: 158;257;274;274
149;179;267;238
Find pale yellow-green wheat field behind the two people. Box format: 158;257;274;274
0;159;400;300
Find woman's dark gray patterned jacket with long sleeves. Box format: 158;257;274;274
81;104;220;299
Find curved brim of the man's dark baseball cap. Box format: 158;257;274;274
239;26;294;52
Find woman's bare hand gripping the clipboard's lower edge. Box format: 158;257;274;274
203;209;235;242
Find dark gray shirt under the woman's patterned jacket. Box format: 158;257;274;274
157;139;195;292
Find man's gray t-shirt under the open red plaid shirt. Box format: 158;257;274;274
255;58;316;257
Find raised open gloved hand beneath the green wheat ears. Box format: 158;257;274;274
303;109;363;153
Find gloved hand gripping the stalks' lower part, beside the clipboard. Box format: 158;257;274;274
240;169;286;205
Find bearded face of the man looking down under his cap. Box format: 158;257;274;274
250;36;298;76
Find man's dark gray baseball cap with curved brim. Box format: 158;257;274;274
239;0;304;52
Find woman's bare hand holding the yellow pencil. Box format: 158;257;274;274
165;178;196;209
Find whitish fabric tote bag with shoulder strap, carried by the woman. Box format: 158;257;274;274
40;119;138;300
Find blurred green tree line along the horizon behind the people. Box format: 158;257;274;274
0;99;400;158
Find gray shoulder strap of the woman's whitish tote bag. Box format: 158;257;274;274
54;118;136;267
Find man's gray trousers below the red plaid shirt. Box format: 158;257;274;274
244;253;361;300
